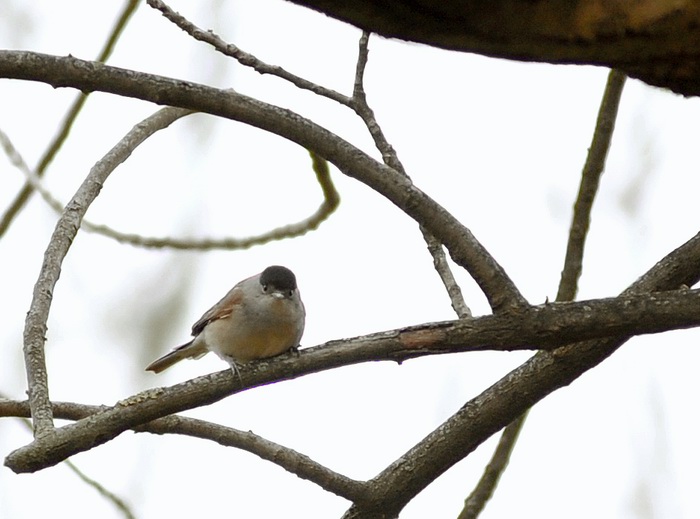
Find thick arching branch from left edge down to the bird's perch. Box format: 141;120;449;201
0;51;519;310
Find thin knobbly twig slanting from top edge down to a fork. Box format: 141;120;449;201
147;0;350;106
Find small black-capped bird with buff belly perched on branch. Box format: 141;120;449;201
146;265;306;373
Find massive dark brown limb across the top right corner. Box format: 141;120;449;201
284;0;700;96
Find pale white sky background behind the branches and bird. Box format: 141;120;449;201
0;0;700;519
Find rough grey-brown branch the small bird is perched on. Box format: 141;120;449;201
5;290;700;472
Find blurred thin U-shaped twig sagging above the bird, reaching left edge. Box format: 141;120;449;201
0;130;340;250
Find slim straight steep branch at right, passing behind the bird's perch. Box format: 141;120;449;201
459;70;625;519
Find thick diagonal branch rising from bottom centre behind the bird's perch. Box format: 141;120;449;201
345;234;700;518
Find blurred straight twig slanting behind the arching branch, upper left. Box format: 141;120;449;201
0;0;140;237
